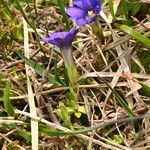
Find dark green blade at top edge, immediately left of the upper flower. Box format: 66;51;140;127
57;0;70;30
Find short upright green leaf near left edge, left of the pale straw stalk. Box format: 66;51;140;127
3;82;14;116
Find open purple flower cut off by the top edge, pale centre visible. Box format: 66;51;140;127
66;0;101;26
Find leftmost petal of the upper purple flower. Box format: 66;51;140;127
66;7;86;19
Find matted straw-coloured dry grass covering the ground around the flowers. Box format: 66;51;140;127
0;0;150;150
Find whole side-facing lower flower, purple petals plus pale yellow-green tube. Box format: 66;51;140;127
42;27;78;85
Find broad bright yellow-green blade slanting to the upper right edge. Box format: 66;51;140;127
116;24;150;47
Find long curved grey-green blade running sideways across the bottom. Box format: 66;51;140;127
0;115;146;138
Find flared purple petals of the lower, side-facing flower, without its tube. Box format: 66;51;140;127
42;27;78;50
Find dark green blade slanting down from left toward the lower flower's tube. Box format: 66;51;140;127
16;51;62;86
